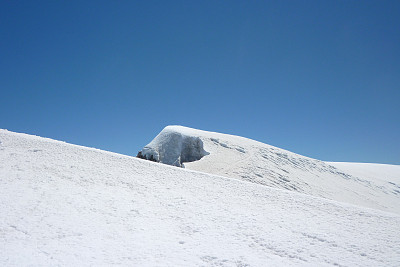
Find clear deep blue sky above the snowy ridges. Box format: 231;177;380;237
0;0;400;164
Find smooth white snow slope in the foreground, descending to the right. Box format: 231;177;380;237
0;130;400;266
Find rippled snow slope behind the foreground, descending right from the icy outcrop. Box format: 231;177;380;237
140;126;400;216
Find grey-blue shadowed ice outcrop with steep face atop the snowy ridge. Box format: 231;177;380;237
138;126;209;167
